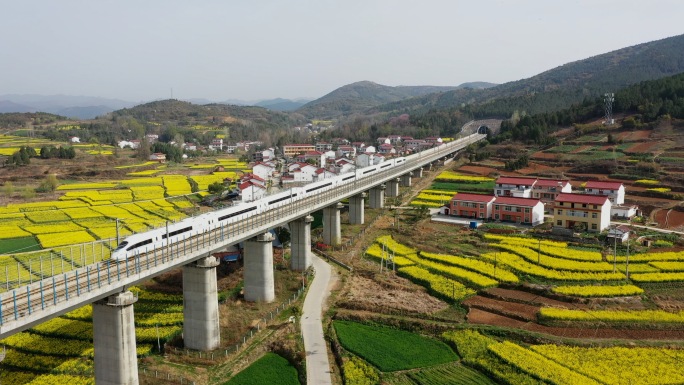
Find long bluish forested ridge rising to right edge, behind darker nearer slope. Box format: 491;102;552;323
367;35;684;116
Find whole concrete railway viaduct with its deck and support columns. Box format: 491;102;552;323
0;128;486;385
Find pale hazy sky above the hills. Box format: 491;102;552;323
0;0;684;102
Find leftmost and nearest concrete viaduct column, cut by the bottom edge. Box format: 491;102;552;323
93;291;138;385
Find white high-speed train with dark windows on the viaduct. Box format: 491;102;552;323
111;134;478;261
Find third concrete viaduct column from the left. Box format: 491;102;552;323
244;233;275;302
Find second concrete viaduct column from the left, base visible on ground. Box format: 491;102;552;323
183;257;221;350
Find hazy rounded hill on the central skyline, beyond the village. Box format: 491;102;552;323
297;81;494;118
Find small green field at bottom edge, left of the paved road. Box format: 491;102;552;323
224;353;300;385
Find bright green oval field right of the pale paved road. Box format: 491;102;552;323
334;321;458;372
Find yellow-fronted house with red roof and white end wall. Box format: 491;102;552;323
553;193;612;231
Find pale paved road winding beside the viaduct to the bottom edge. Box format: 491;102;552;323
301;255;337;385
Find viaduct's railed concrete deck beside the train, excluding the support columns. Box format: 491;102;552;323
0;135;483;339
